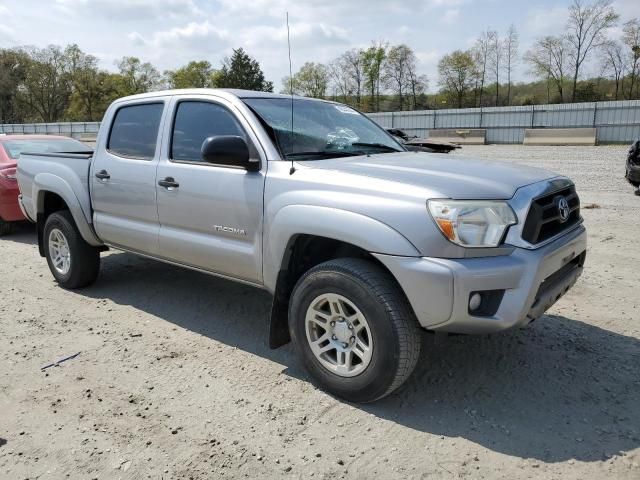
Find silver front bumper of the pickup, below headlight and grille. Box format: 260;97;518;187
375;225;587;333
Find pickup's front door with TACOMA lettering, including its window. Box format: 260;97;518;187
156;96;267;283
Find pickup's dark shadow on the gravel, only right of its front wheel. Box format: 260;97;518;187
364;315;640;462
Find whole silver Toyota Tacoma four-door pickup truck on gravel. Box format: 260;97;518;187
18;90;586;402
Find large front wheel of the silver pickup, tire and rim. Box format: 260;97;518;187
289;258;421;403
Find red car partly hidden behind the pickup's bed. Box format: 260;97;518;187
0;135;90;235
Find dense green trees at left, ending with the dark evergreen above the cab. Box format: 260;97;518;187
0;45;273;123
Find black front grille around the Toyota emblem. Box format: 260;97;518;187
522;185;580;245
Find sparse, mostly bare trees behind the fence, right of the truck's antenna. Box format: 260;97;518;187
282;0;640;111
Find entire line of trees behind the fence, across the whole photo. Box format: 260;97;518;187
0;0;640;123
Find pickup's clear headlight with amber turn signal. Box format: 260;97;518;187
427;200;517;247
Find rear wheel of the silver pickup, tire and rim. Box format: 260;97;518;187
43;210;100;290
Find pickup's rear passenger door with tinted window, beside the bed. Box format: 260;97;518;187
90;98;166;255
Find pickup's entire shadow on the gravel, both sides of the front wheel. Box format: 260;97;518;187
83;254;640;462
